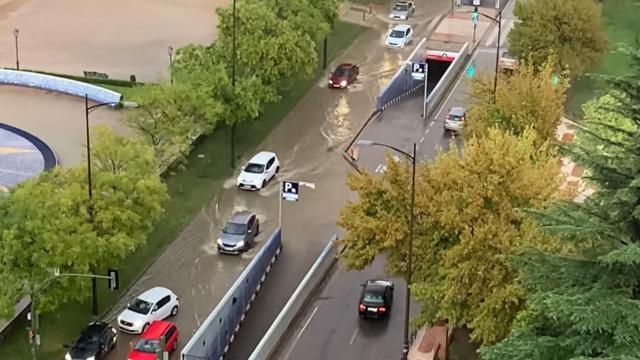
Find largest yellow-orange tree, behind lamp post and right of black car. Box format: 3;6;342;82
338;129;559;343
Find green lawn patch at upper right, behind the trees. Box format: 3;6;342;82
565;0;640;118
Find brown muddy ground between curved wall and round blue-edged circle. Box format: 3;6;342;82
0;85;128;166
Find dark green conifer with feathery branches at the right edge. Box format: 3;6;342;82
482;51;640;360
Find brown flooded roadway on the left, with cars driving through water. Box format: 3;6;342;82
100;0;450;359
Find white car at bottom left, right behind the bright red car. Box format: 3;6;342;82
118;287;180;334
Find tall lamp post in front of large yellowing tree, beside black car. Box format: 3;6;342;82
356;140;417;360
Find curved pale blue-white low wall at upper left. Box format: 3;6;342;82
0;69;122;103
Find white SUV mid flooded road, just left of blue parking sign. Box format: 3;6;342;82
237;151;280;190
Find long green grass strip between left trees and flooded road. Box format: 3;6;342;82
0;22;366;360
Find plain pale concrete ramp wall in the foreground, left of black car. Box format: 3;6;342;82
249;235;338;360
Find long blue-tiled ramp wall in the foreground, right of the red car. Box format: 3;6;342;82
180;229;282;360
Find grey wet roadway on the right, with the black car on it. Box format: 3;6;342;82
273;3;513;360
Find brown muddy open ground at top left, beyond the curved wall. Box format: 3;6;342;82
0;0;231;81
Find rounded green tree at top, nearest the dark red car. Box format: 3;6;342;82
216;0;317;86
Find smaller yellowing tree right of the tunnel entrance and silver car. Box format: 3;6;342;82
464;61;568;143
